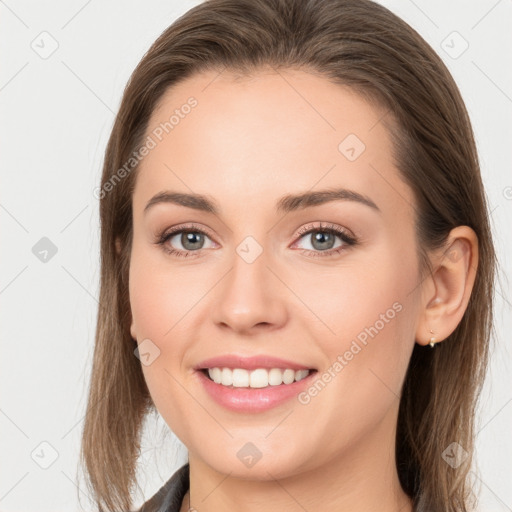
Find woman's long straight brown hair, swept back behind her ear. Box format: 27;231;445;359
81;0;496;512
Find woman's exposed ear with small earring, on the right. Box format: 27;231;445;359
416;226;478;345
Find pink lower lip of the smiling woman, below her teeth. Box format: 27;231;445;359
196;371;317;413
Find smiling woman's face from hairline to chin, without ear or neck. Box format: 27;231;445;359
129;71;420;480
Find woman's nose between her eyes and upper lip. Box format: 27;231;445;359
213;245;290;335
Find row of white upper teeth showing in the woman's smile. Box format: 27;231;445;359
208;368;309;388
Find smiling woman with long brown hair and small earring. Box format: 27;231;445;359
82;0;495;512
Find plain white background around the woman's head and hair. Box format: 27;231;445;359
0;0;512;512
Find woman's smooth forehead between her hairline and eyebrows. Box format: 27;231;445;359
133;70;412;220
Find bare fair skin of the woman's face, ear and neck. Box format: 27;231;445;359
129;69;478;512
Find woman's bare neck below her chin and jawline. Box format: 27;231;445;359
181;410;413;512
